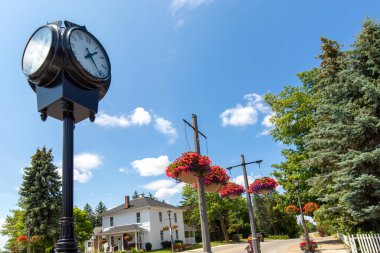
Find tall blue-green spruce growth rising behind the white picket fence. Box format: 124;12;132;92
306;20;380;232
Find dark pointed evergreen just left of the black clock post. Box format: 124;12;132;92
19;147;62;242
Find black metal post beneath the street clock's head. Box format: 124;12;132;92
55;99;79;253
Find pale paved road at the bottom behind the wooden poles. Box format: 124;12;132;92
184;239;299;253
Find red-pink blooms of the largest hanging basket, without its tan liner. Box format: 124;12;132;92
165;152;211;180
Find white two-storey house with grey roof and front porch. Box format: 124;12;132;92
85;196;195;252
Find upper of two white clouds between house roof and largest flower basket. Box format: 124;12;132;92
131;155;170;177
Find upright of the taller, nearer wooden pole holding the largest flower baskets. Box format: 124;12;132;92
192;114;211;253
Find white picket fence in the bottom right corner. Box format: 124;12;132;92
338;234;380;253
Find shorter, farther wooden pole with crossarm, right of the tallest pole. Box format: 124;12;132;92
226;155;263;253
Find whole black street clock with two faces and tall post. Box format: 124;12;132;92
22;21;111;253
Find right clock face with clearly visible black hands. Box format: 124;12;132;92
69;29;110;79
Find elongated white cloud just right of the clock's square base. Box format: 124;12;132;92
95;107;152;128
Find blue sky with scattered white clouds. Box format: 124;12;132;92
0;0;380;248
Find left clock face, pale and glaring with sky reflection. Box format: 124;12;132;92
22;26;53;75
